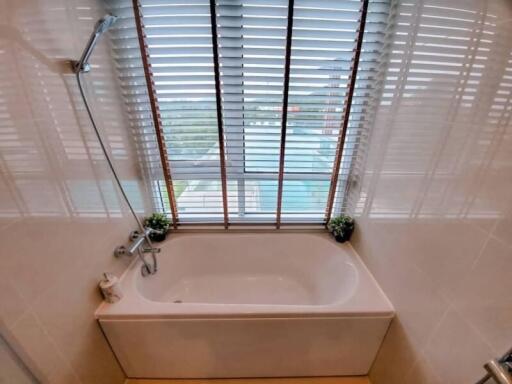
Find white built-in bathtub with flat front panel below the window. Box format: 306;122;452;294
96;233;394;378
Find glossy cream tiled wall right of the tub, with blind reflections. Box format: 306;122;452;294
353;0;512;384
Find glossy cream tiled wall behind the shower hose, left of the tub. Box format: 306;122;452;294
0;0;152;384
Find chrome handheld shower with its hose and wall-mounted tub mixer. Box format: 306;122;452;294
71;14;160;276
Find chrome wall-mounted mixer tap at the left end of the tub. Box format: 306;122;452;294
114;228;160;276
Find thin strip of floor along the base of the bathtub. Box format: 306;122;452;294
125;376;370;384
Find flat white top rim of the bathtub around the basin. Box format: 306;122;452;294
95;229;395;320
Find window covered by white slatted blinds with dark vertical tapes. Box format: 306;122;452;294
110;0;389;226
